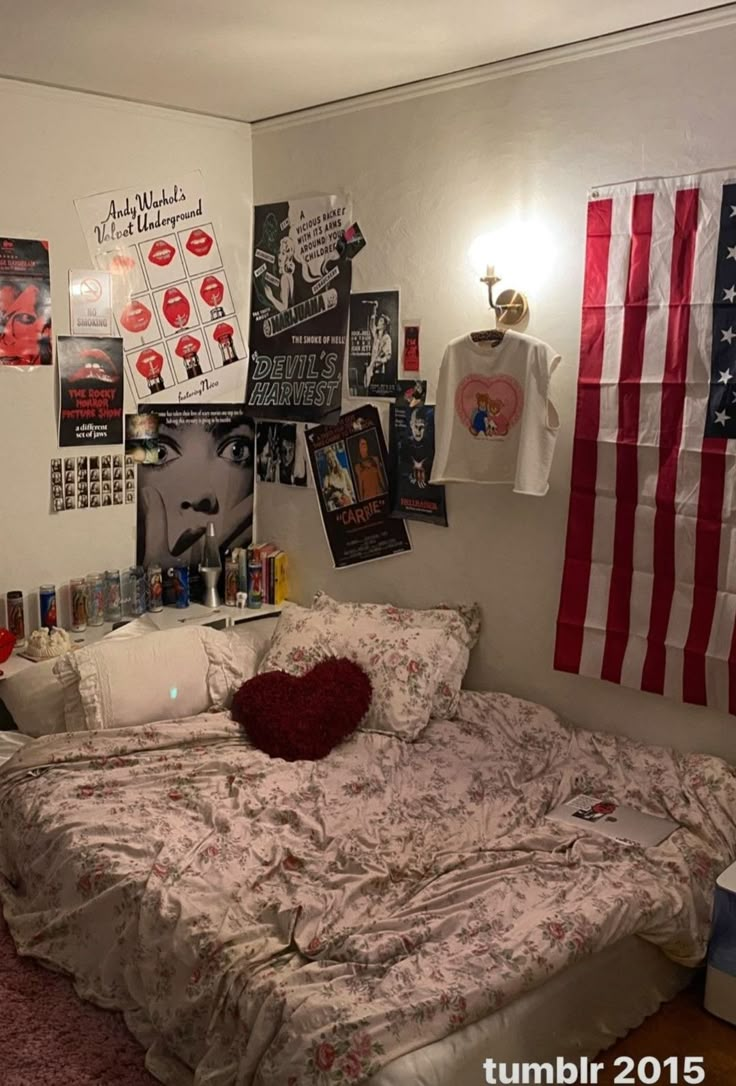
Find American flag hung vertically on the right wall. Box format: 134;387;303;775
555;168;736;712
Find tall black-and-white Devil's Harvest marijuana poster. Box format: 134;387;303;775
245;195;352;422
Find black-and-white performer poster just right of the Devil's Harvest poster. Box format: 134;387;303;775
347;290;401;400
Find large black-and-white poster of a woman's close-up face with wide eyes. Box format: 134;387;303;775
137;403;255;602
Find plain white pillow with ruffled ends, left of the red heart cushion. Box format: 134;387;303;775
54;627;256;732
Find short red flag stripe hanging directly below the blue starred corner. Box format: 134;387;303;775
683;438;726;705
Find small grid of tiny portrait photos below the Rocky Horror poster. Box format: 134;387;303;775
50;453;136;513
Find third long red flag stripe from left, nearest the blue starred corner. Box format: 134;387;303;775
642;189;699;694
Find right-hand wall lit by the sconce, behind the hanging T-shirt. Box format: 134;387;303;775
254;19;736;760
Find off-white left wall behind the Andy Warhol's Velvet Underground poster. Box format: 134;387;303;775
0;79;252;622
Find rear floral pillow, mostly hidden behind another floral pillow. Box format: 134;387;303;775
313;592;481;720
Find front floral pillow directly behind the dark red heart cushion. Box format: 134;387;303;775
258;604;464;740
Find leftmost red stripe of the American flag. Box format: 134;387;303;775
555;200;613;671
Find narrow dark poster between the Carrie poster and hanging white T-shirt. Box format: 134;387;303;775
389;395;447;527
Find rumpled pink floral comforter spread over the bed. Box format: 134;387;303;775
0;694;736;1086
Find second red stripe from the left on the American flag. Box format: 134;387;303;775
600;192;655;682
